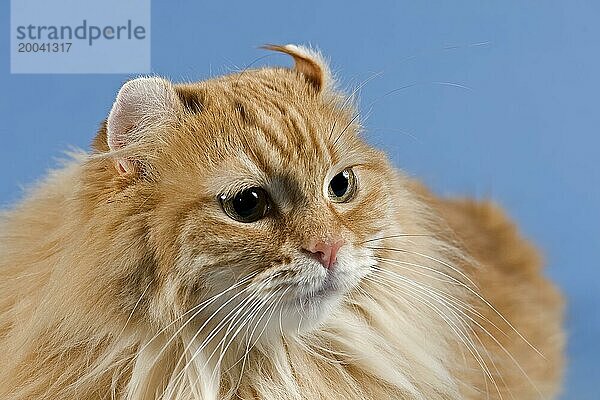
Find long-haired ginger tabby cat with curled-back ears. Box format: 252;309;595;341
0;45;565;400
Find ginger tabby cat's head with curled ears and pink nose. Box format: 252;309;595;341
97;45;395;342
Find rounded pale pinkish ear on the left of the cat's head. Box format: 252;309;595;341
106;77;182;174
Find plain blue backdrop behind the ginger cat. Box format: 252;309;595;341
0;1;600;400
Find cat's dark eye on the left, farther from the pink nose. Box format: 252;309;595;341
219;187;270;222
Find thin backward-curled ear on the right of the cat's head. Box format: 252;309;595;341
262;44;332;92
